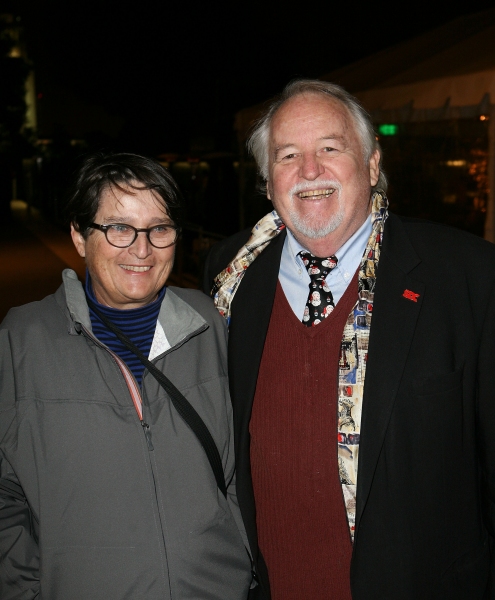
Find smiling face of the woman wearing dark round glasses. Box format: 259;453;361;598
71;188;175;309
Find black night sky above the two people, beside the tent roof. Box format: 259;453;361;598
2;0;493;154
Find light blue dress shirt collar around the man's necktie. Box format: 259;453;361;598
278;215;372;321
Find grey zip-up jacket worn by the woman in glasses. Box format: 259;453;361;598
0;270;251;600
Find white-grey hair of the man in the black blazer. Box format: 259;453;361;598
247;79;388;192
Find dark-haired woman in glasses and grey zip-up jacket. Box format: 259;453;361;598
0;154;252;600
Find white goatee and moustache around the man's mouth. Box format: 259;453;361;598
289;180;344;240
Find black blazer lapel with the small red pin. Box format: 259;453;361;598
356;215;425;541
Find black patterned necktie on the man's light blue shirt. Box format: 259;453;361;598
300;252;338;327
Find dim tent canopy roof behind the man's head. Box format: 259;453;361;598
235;8;495;139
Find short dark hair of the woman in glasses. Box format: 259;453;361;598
66;152;183;237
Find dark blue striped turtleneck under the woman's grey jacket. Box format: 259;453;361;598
86;271;167;386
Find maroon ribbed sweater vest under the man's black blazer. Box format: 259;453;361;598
250;273;357;600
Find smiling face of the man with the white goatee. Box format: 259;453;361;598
268;93;380;256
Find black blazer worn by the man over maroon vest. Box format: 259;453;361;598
205;214;495;600
